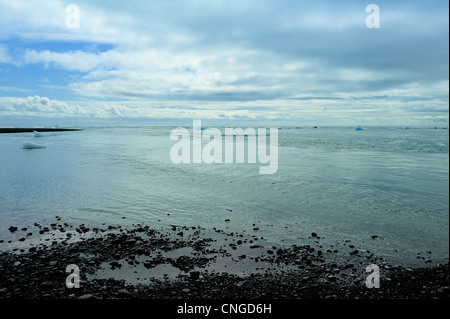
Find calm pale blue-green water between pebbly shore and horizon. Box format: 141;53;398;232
0;126;449;265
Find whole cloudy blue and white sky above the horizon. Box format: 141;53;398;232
0;0;449;126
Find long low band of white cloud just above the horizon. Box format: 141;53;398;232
0;96;448;126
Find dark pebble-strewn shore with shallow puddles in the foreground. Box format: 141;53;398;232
0;218;449;300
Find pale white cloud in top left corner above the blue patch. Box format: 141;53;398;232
0;0;140;44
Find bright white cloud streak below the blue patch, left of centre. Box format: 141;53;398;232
20;49;292;98
